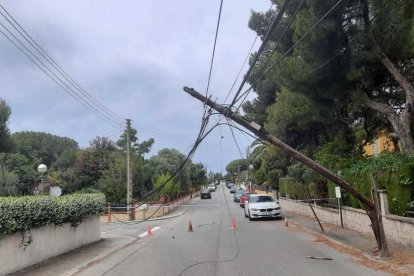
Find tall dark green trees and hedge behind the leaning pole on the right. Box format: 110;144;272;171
229;0;414;215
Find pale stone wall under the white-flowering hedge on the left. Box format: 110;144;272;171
0;216;101;275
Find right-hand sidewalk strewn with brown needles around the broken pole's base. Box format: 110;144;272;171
284;212;414;275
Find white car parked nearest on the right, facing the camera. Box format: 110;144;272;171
244;194;282;221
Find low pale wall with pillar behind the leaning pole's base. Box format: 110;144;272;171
279;191;414;247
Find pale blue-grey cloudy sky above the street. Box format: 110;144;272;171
0;0;271;173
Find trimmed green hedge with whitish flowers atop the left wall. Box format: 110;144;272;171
0;193;105;238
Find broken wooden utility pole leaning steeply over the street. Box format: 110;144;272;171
184;87;385;256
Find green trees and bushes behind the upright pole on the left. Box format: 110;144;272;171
0;99;207;204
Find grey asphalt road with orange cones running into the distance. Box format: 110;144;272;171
78;185;385;275
